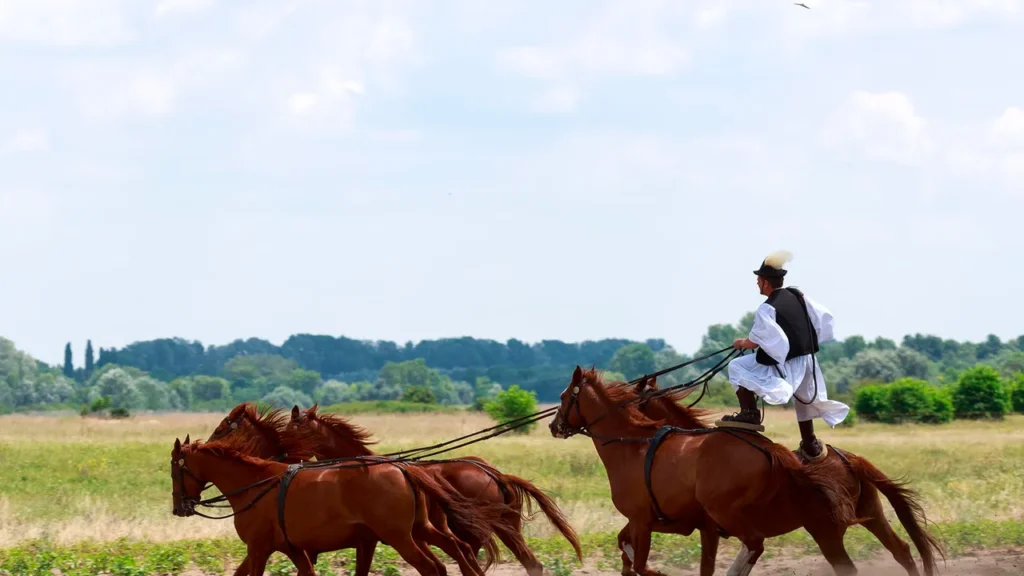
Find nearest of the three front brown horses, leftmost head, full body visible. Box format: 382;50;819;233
171;422;512;576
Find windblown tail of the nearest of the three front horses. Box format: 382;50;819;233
406;465;515;572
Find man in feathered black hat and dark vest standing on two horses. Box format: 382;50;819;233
720;251;850;459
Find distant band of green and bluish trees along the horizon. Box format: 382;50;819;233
0;314;1024;411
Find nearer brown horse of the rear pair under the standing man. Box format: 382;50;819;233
550;366;856;576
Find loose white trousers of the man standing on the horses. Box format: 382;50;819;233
729;354;850;427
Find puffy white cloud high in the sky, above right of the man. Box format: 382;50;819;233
823;90;935;164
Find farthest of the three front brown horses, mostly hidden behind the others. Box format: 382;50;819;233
284;405;583;576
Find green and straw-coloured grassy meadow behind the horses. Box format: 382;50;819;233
0;410;1024;576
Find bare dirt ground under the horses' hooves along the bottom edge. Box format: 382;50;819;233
176;550;1024;576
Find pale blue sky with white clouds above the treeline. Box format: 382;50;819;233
0;0;1024;362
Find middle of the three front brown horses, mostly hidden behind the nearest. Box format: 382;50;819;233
198;403;495;576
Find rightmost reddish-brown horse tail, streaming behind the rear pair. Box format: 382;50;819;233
844;452;946;576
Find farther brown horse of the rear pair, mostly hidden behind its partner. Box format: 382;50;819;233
620;378;945;576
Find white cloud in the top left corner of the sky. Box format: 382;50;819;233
0;0;134;46
